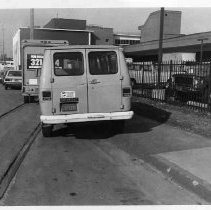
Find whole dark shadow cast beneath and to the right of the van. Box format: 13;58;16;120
50;102;171;139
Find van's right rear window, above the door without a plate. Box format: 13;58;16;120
89;51;118;75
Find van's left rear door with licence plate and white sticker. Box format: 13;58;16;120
51;49;87;115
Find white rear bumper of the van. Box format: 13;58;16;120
40;111;134;124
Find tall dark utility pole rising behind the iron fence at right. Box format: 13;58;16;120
158;7;164;85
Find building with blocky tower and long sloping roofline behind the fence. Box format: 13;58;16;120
124;10;211;61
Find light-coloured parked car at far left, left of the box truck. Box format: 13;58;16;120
4;70;22;90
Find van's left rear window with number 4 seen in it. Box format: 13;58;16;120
54;52;84;76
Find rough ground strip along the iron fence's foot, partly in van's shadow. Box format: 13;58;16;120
132;98;211;138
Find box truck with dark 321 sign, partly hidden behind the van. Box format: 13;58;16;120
14;40;68;103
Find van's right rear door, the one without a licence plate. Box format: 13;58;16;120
86;49;122;113
